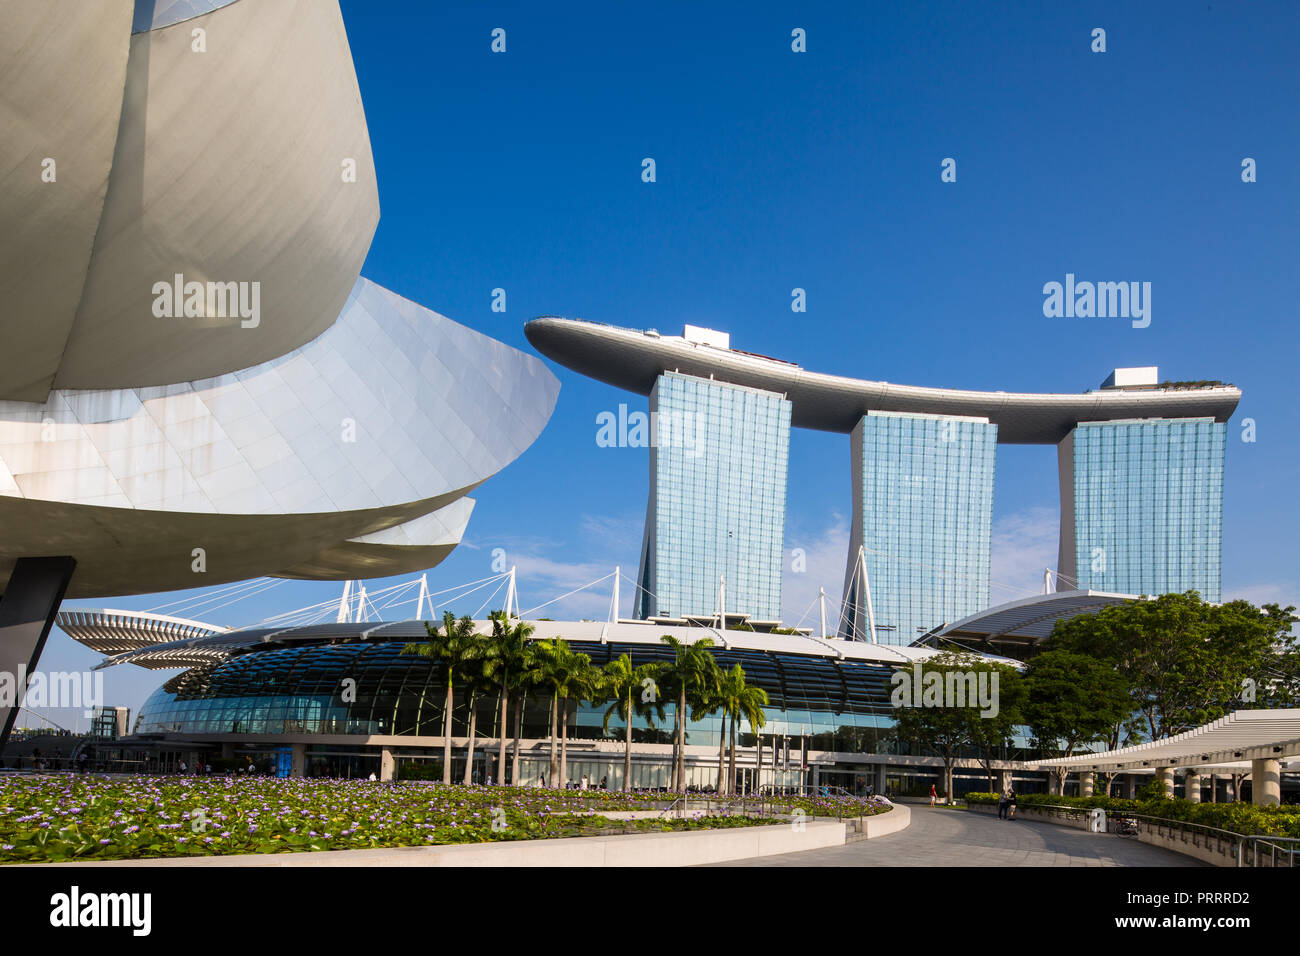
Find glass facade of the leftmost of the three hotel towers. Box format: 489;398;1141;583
636;372;790;620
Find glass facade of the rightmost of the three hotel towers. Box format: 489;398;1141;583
1060;419;1227;601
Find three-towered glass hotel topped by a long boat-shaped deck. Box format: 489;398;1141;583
525;317;1242;644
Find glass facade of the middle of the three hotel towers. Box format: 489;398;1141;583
841;412;997;644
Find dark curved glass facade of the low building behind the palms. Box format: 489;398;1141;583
135;641;906;753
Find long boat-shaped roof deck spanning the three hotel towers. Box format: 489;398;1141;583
524;317;1242;445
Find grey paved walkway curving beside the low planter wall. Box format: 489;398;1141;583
719;805;1206;866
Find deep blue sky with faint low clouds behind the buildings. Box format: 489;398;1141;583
20;0;1300;723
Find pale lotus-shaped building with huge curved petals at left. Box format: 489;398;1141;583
0;0;559;738
